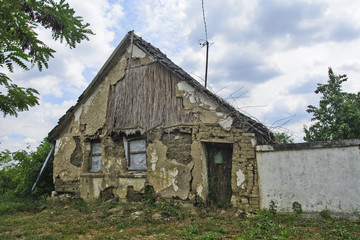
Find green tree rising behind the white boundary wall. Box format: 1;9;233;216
304;68;360;141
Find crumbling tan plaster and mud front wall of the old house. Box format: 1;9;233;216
54;43;258;207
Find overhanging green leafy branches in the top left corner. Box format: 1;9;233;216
0;0;94;116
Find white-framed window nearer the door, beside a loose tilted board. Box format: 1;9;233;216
124;138;146;171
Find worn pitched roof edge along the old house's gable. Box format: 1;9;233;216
48;31;274;143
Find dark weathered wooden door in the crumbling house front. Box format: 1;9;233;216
206;143;233;207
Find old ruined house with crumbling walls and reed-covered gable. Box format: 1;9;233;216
48;32;273;206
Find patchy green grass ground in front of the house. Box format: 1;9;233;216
0;200;360;240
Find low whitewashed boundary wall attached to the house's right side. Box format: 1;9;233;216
256;140;360;216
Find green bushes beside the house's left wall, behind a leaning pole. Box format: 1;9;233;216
0;139;54;199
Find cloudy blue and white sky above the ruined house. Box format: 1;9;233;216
0;0;360;151
